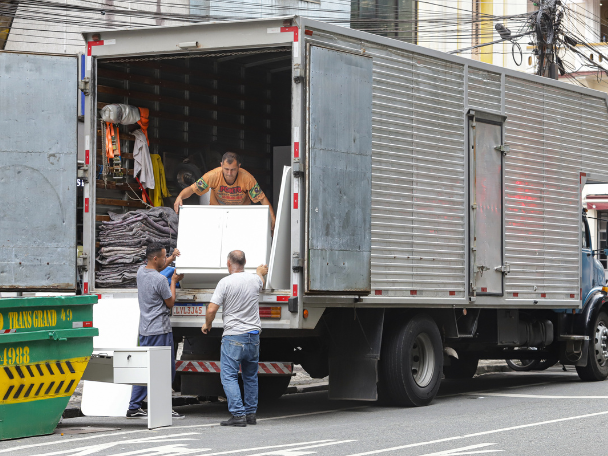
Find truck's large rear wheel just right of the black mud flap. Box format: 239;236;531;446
381;314;443;407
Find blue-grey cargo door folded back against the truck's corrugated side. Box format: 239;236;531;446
306;45;372;294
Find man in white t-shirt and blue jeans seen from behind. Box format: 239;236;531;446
201;250;268;427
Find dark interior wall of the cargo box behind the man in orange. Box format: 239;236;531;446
95;48;291;288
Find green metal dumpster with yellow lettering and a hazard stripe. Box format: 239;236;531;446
0;295;98;440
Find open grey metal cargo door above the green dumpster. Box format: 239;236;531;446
0;53;78;291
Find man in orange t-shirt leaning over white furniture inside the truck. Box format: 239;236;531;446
173;152;275;231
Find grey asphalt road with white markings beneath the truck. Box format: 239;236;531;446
0;368;608;456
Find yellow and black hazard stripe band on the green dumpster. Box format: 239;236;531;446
0;357;89;404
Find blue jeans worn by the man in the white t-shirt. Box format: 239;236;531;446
220;333;260;416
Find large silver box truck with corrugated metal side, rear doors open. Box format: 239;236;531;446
0;16;608;405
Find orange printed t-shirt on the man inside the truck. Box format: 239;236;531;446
191;167;266;205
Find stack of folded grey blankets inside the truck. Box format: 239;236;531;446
95;207;177;288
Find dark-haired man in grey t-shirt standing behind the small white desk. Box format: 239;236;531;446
127;243;184;418
